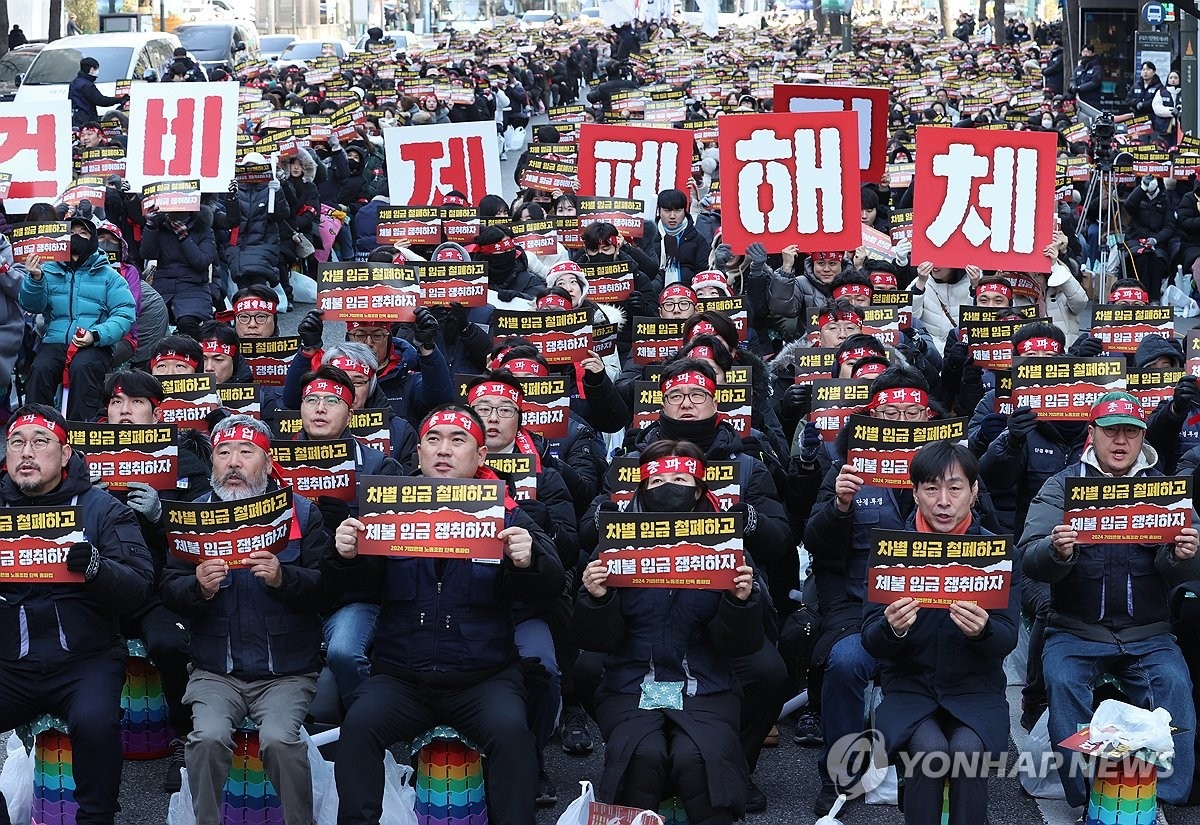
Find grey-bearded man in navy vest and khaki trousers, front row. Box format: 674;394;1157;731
162;415;330;825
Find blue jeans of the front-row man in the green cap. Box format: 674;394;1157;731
1043;627;1196;807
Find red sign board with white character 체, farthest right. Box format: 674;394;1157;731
912;126;1058;272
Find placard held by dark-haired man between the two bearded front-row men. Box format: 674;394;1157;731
67;421;179;490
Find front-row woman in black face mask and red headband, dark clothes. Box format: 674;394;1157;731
575;441;763;825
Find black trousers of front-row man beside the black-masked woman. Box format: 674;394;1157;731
334;666;538;825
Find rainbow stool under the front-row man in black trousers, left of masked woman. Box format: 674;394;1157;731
413;725;487;825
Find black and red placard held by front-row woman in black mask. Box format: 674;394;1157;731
596;510;745;590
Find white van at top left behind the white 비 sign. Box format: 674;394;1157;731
16;31;180;103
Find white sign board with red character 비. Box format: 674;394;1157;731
125;83;239;192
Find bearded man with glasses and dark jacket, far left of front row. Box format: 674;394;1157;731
0;404;154;825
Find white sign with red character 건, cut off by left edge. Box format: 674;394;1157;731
0;101;73;215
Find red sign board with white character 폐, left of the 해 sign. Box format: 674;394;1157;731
576;124;695;221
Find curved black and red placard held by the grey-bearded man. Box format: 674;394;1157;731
162;489;292;565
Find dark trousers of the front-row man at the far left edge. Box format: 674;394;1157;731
0;646;125;825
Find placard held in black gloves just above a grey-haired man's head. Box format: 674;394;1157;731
317;263;421;326
